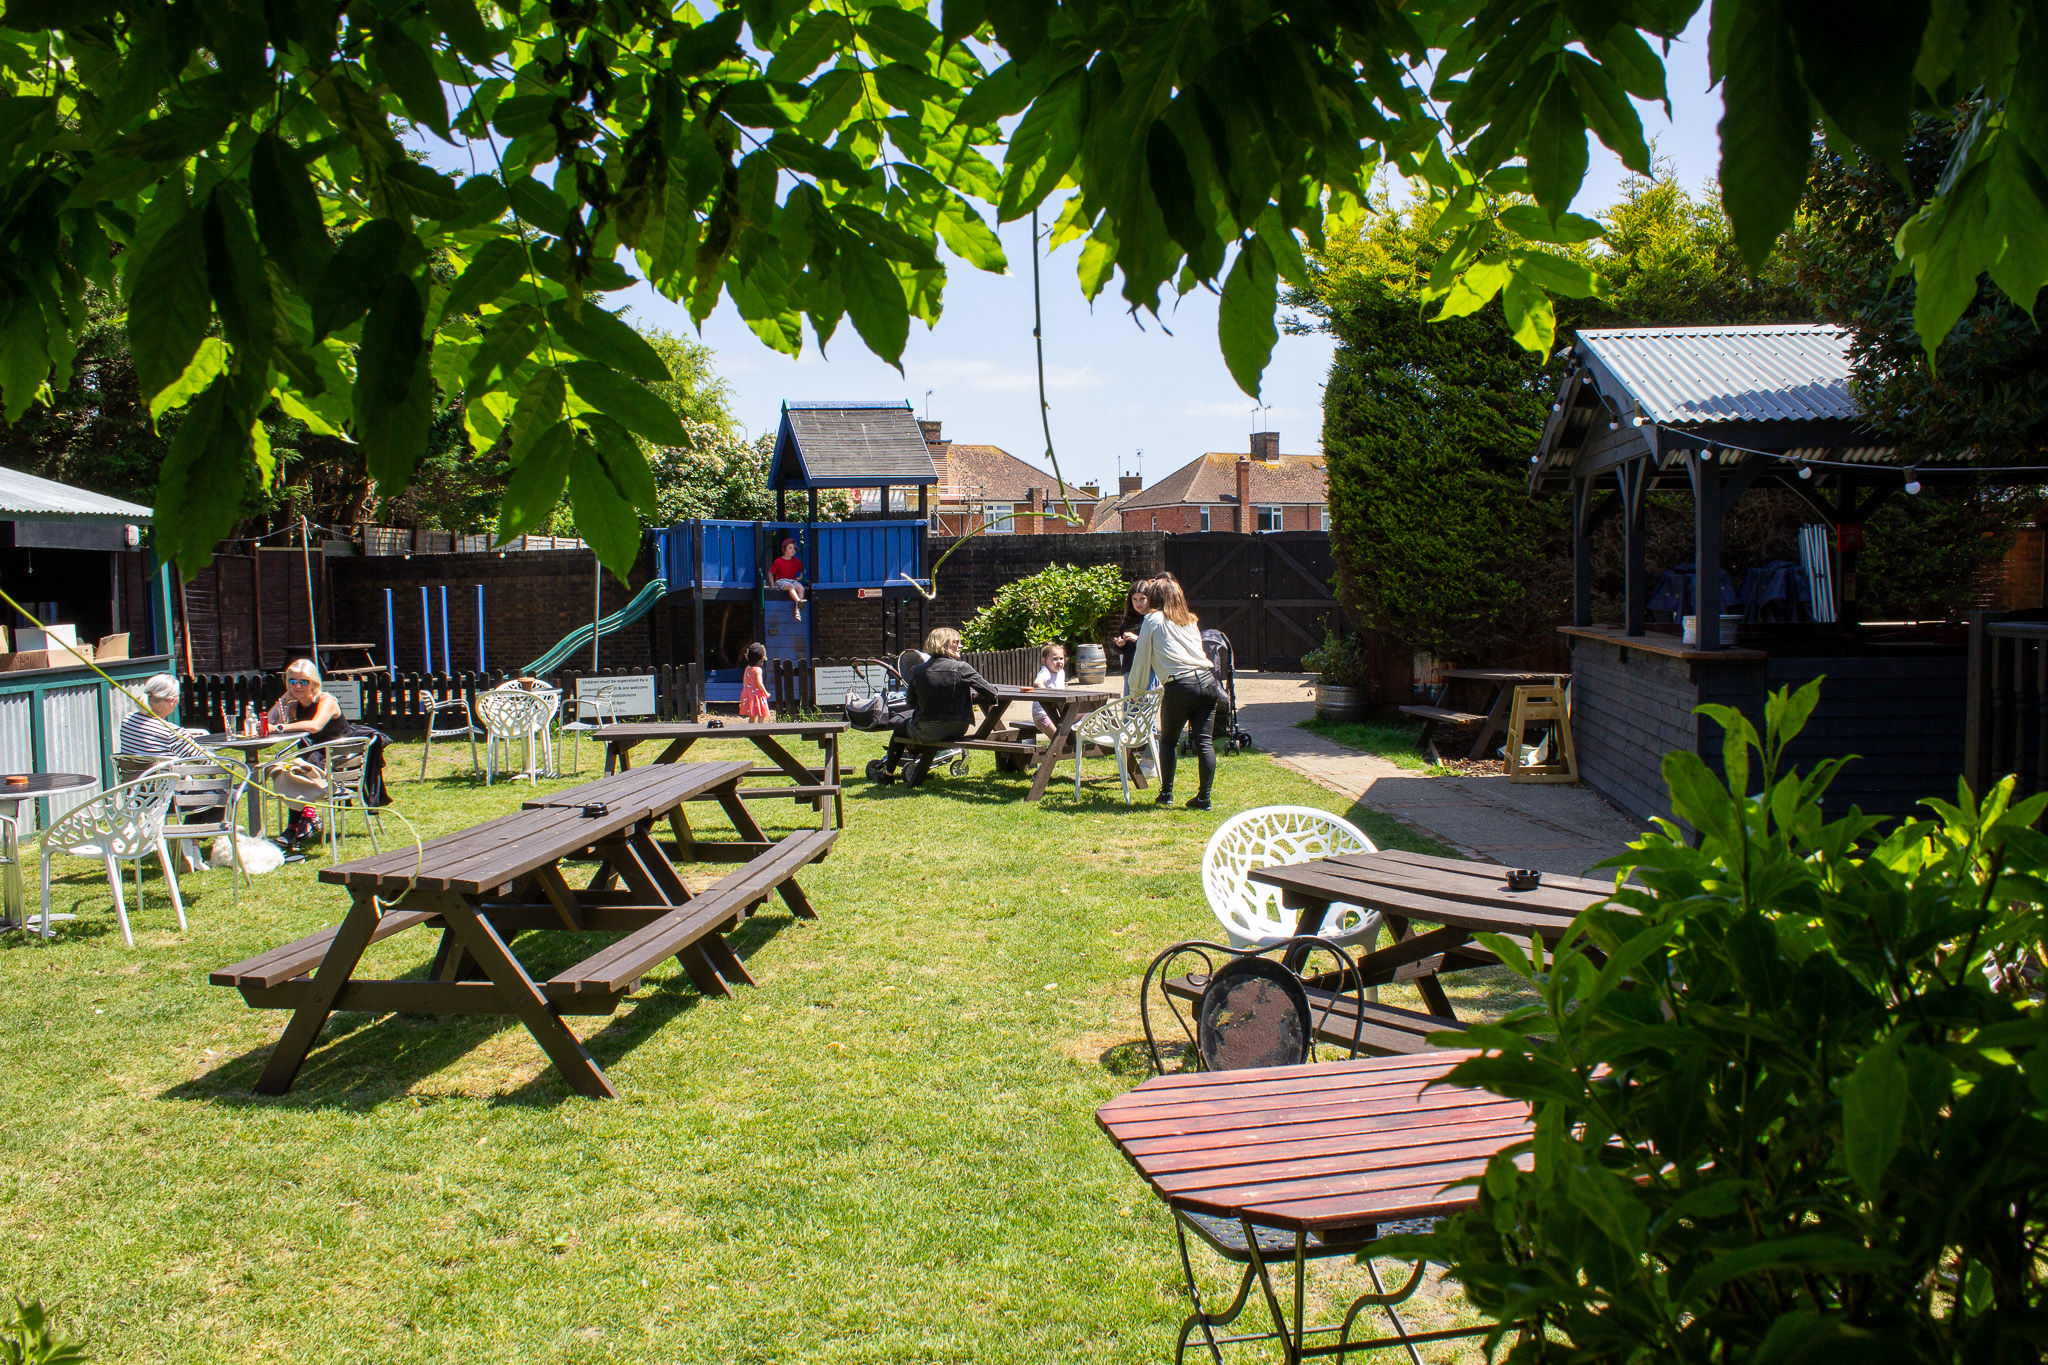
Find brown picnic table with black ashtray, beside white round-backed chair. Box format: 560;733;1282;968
1251;849;1614;1031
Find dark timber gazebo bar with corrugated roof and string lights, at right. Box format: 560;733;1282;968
1530;323;2023;819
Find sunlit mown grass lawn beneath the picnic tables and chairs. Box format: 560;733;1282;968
0;735;1499;1361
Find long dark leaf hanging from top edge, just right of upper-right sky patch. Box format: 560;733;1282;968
1712;0;1812;270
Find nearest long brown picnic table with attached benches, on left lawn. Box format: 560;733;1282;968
211;763;840;1099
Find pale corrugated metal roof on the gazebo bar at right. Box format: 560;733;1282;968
1579;323;1862;424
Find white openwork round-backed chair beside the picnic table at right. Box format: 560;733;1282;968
1202;806;1380;948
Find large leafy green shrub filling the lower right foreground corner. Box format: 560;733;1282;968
1409;686;2048;1365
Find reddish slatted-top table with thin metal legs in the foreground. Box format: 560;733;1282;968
1096;1052;1532;1361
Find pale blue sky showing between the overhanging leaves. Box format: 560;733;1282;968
448;8;1720;497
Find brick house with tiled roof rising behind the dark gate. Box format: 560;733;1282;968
1098;432;1329;532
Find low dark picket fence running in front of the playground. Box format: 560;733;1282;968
180;649;1038;733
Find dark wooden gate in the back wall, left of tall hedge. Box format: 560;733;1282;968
1165;530;1337;673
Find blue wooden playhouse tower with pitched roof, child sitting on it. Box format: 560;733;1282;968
655;403;938;702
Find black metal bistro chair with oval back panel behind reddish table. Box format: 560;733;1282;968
1139;937;1434;1365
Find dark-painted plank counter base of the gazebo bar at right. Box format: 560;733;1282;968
1559;624;1968;821
